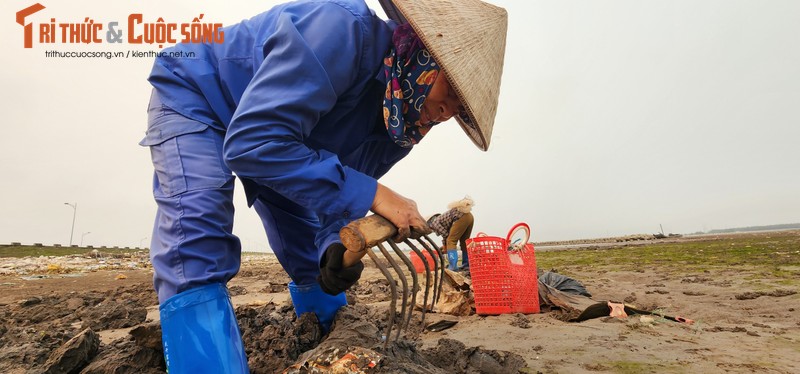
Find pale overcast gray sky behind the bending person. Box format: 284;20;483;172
0;0;800;250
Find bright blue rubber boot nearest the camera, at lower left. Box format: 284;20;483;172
159;283;250;374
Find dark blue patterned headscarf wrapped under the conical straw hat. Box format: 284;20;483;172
383;23;439;148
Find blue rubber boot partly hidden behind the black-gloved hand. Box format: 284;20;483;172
289;282;347;334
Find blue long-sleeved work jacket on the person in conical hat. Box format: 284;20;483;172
142;0;409;251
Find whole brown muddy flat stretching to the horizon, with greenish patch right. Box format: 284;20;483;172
0;231;800;373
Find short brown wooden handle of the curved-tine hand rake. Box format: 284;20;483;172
339;214;397;267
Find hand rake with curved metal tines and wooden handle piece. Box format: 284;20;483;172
339;215;445;350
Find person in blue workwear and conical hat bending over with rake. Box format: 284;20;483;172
140;0;507;373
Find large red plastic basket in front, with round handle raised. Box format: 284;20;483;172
467;223;539;315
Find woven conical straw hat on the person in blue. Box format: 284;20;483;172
379;0;508;151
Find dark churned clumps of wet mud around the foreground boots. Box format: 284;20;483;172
0;282;525;374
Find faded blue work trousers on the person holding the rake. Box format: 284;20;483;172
140;91;320;303
